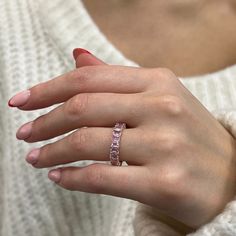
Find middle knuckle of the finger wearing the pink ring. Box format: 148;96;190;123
68;129;89;152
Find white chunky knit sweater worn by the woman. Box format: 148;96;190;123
0;0;236;236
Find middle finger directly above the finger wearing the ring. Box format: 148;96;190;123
16;93;143;143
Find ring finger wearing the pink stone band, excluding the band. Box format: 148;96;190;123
26;127;146;168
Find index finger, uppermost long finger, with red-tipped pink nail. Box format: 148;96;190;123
9;65;150;110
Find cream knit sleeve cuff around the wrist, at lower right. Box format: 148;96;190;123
133;109;236;236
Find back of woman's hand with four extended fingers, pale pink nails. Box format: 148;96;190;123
10;52;236;228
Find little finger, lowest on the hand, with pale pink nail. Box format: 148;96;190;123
48;163;147;200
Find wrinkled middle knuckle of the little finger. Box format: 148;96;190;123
85;163;105;193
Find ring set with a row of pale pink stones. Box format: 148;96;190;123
110;122;126;166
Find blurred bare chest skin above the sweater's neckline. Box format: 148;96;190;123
83;0;236;76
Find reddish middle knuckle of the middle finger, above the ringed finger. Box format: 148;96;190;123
65;93;89;119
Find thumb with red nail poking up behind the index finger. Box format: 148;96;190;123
73;48;106;68
